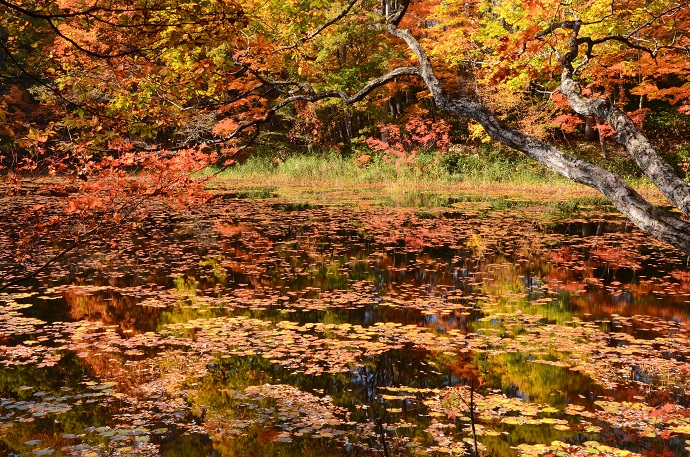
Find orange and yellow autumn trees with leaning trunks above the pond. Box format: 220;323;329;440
0;0;690;262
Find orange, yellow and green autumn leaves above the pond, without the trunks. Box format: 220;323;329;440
0;0;690;164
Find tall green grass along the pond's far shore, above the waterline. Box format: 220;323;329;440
206;150;650;189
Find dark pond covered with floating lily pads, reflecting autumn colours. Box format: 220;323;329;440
0;188;690;456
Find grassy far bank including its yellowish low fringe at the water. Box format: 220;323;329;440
206;147;676;208
